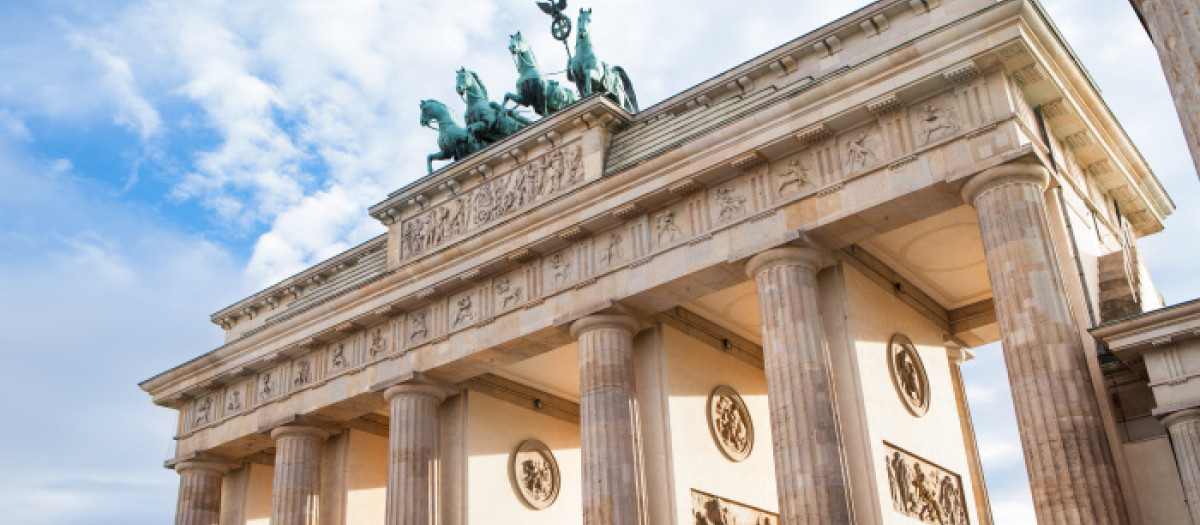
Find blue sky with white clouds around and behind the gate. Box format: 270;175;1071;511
0;0;1200;525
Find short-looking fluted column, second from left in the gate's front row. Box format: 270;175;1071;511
271;426;329;525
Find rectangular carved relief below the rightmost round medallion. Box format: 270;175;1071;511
883;442;971;525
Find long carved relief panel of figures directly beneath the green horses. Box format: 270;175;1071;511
400;144;583;259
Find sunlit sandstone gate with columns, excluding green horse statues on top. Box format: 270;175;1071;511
142;0;1200;525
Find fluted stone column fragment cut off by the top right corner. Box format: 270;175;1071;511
1133;0;1200;178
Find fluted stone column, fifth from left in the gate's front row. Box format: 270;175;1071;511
746;248;850;525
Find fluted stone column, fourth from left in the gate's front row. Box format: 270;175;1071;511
571;315;646;525
